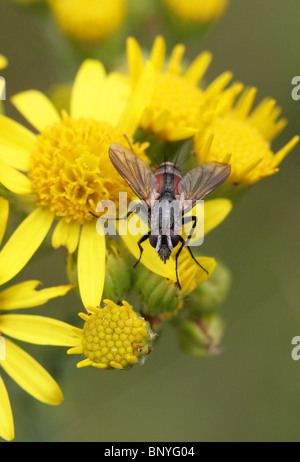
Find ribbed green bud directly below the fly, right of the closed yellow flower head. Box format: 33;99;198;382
134;265;182;316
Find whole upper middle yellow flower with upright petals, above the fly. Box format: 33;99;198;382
127;36;231;141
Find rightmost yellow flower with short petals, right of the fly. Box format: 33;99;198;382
194;85;299;185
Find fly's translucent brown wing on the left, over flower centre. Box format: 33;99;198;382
109;143;158;206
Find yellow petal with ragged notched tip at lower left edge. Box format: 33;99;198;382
0;281;74;311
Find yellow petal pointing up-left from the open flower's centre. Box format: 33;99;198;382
11;90;60;132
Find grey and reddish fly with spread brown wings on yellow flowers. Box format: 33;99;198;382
105;143;231;289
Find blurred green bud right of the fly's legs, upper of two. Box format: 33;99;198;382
185;262;231;315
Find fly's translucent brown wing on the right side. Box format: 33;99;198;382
178;162;231;212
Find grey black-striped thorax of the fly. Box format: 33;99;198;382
150;199;182;235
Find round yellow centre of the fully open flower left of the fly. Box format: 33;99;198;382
29;114;143;224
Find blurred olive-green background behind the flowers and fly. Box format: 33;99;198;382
0;0;300;442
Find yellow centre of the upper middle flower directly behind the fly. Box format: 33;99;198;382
141;73;204;139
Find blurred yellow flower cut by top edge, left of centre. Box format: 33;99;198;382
48;0;127;42
